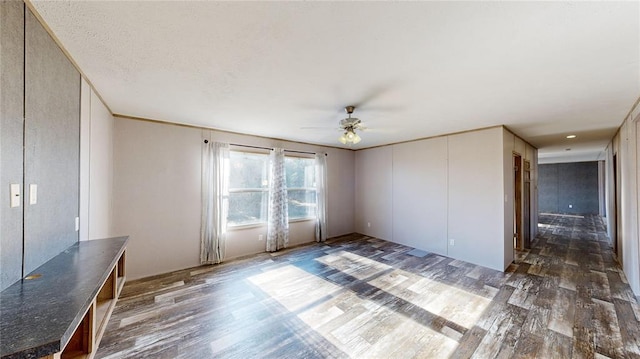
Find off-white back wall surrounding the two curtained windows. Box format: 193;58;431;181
113;117;354;279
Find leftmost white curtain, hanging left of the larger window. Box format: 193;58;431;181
200;141;229;264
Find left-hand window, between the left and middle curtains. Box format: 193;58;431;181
227;151;269;226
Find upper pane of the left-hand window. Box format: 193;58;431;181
229;151;268;189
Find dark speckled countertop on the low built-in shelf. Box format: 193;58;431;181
0;237;129;358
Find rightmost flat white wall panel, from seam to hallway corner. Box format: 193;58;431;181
448;127;510;270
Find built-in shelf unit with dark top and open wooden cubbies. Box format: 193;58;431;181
0;237;128;359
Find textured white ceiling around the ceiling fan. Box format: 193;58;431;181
32;1;640;159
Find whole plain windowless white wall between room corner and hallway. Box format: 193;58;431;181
355;127;535;270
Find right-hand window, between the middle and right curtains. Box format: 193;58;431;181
284;157;316;219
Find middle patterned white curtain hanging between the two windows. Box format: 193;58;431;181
267;148;289;252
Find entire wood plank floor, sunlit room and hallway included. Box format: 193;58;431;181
96;215;640;358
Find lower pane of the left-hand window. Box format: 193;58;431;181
227;191;268;226
